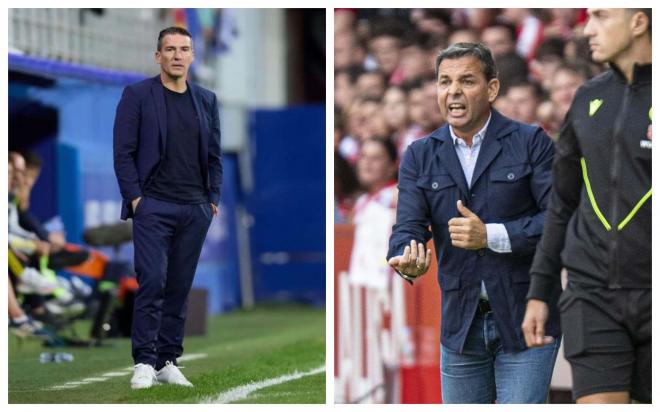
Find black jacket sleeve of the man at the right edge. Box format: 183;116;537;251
527;114;582;302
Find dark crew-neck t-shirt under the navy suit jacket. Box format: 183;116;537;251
145;87;208;204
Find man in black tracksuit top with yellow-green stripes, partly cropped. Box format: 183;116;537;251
523;9;652;403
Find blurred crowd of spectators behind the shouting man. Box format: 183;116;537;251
334;8;604;223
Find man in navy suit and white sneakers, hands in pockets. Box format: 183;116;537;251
114;27;222;389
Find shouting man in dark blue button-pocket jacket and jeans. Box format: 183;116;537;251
388;43;560;403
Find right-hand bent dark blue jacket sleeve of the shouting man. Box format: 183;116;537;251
504;128;554;256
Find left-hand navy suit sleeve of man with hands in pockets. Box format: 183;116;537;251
113;86;142;203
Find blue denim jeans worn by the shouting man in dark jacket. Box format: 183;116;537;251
441;312;560;403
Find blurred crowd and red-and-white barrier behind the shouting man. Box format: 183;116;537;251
334;8;603;403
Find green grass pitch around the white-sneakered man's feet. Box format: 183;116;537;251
9;305;325;403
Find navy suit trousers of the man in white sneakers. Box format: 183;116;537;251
131;196;213;369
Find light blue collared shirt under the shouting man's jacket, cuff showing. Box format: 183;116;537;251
449;115;511;299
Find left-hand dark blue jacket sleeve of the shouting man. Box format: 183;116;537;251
387;147;431;259
